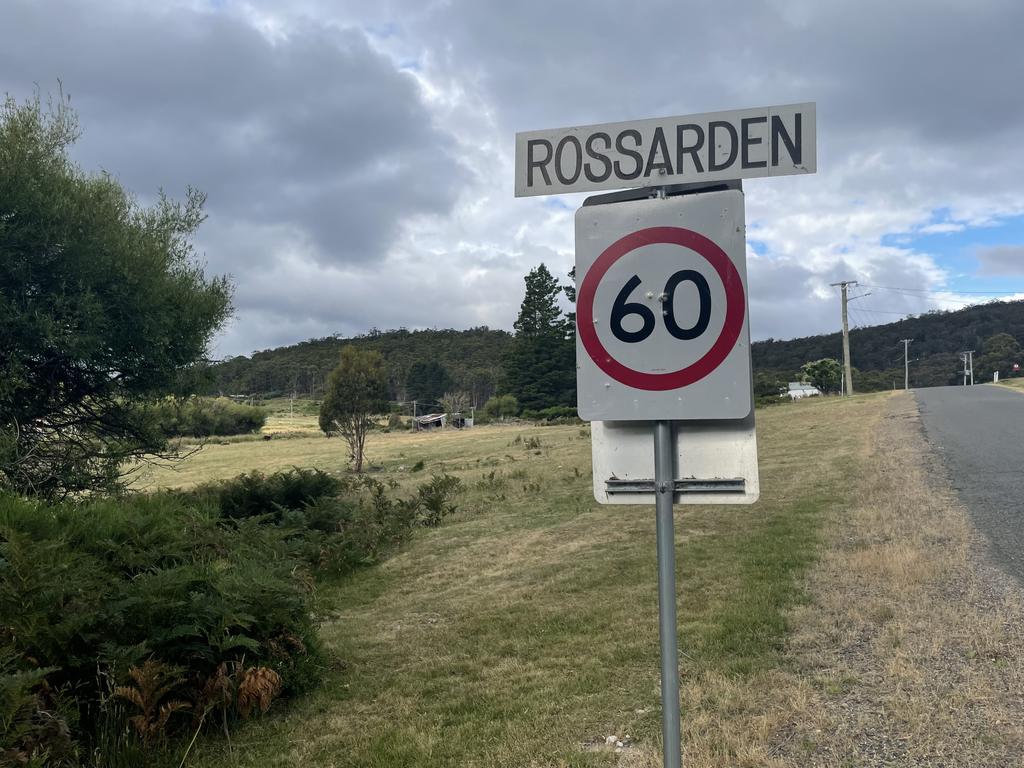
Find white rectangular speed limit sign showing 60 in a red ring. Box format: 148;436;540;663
575;189;753;421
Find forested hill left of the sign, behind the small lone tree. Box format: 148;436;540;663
212;328;512;404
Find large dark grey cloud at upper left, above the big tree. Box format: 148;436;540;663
0;2;465;269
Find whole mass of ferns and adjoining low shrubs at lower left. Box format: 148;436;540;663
0;469;462;765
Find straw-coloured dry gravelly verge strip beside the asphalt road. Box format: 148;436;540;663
776;395;1024;768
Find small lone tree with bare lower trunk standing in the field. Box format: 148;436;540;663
319;345;388;472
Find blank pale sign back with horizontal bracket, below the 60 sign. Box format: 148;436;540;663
591;412;761;504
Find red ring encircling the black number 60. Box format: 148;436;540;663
577;226;746;392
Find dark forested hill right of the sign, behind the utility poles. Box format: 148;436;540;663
753;301;1024;390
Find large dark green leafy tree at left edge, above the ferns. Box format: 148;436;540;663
0;96;230;498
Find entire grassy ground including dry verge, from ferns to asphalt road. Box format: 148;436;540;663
156;394;1024;768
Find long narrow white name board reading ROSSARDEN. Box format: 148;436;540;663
515;102;817;198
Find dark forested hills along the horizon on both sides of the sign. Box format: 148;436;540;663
211;301;1024;404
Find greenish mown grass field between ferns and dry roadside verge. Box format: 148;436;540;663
165;396;880;768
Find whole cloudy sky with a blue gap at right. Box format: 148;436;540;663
6;0;1024;355
